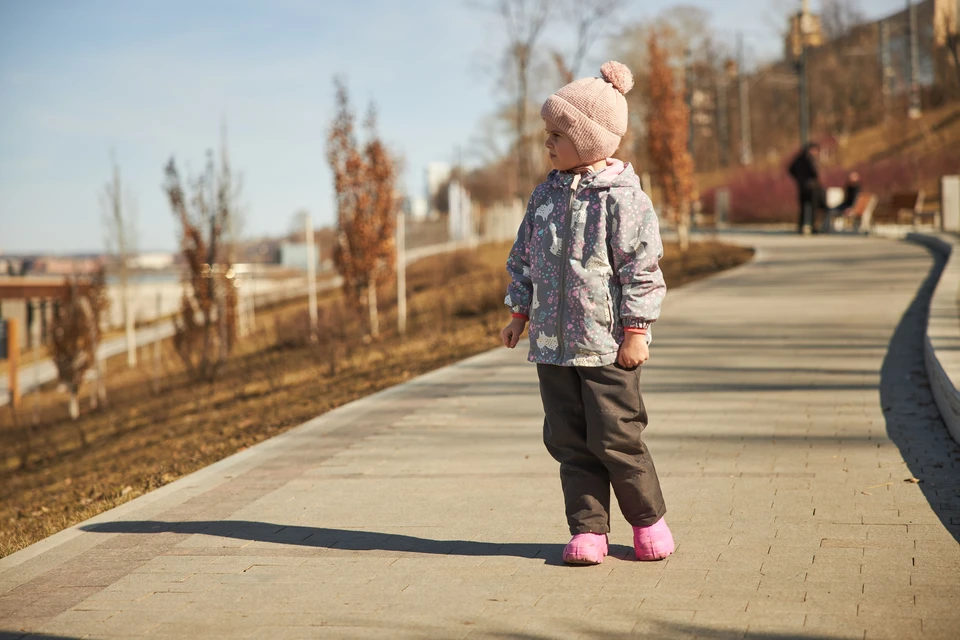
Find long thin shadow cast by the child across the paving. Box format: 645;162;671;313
81;520;633;566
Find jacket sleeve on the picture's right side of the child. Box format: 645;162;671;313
607;187;667;328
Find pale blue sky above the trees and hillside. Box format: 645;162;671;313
0;0;903;253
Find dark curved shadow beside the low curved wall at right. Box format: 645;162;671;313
880;239;960;541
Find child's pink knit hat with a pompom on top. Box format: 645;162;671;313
540;60;633;164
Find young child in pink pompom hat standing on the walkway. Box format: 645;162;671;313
500;62;674;564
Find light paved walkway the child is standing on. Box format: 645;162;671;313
0;236;960;640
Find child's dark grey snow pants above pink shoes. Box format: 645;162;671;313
537;364;666;534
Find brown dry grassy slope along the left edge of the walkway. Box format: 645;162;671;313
0;242;752;556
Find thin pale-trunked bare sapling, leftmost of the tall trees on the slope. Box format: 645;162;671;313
103;153;137;367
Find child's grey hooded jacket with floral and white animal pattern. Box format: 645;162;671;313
504;160;667;367
